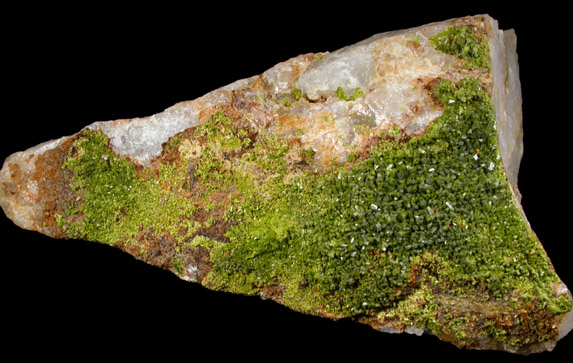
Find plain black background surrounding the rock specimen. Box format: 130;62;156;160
0;2;573;362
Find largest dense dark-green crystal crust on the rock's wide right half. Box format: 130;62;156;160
207;79;568;324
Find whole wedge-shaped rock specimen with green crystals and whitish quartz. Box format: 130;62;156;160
0;15;573;354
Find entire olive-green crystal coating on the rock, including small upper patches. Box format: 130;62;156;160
0;17;572;352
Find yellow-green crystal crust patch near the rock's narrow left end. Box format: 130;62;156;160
56;130;197;245
